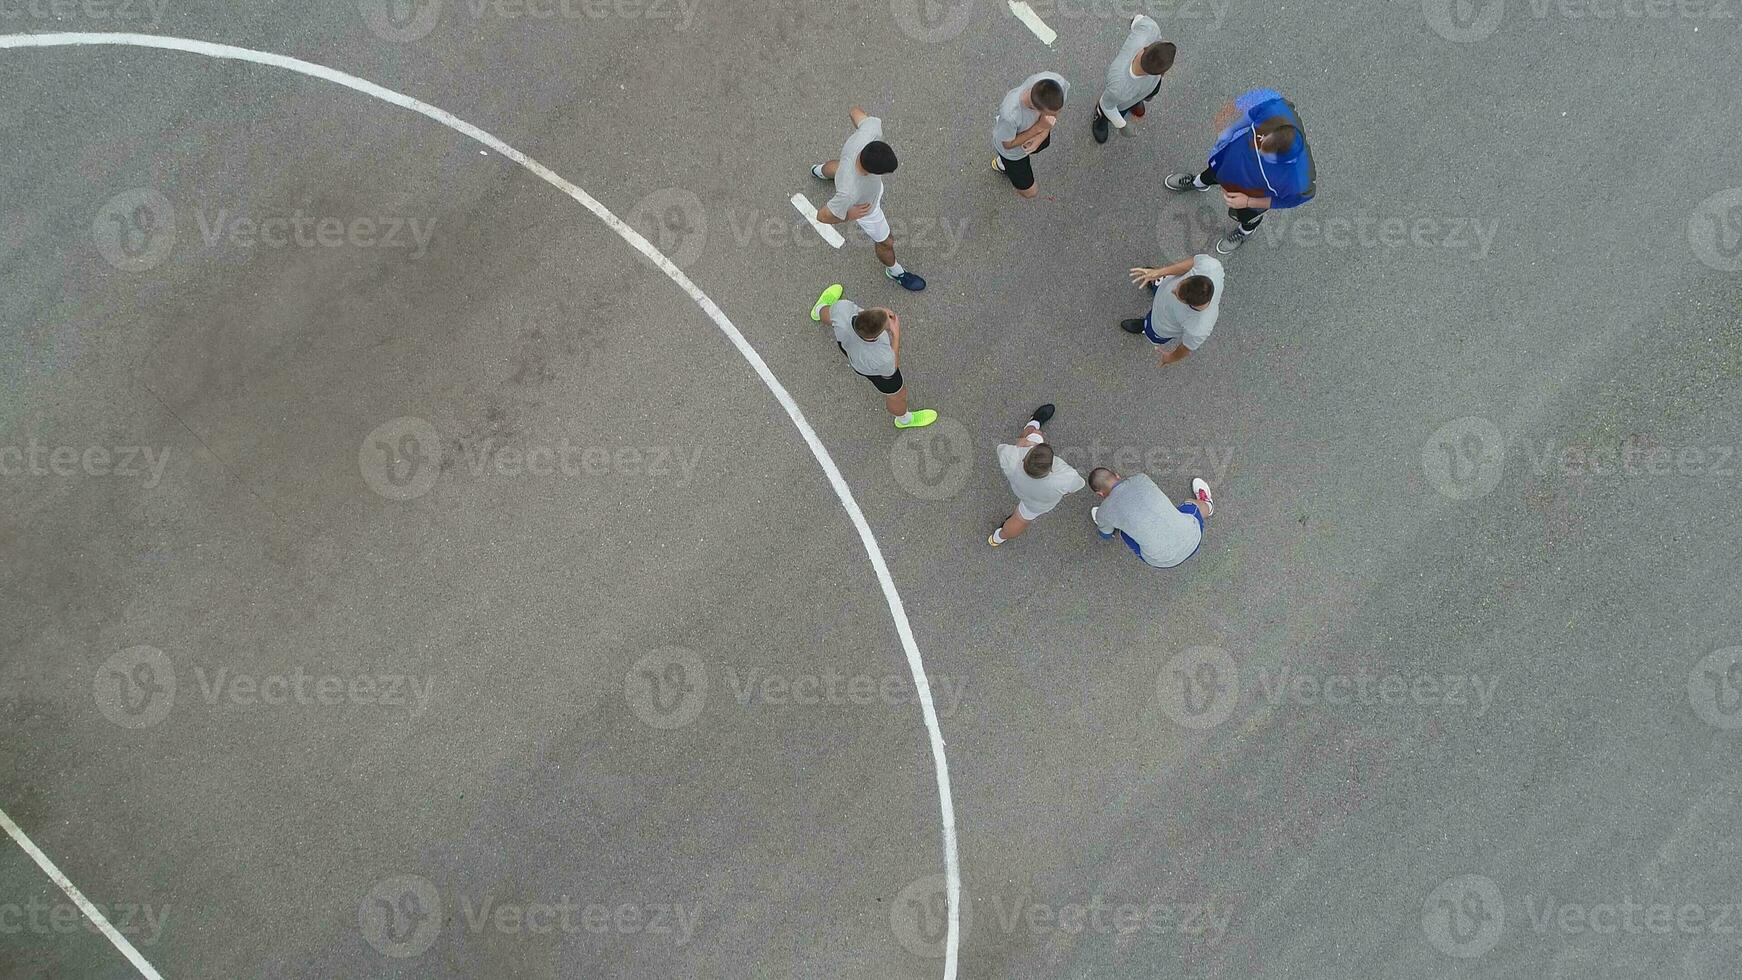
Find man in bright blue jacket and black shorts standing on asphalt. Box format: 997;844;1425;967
1162;89;1319;256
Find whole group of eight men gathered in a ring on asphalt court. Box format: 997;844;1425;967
797;14;1315;567
